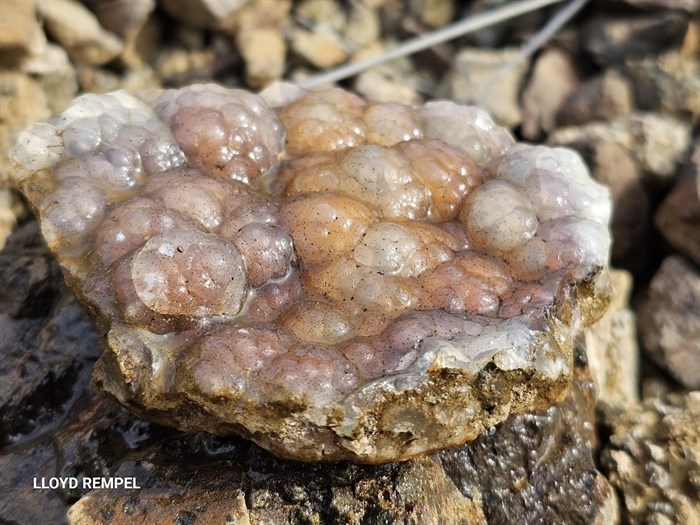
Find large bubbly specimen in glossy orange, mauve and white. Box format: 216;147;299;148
11;84;610;463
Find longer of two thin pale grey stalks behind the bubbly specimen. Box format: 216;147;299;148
299;0;564;89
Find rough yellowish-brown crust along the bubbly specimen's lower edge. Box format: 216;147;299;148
94;269;609;463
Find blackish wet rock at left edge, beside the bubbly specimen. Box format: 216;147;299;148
0;223;97;446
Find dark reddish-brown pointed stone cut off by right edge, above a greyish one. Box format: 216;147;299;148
654;144;700;265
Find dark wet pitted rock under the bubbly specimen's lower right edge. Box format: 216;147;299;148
440;352;618;525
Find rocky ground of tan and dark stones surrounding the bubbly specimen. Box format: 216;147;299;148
0;0;700;524
